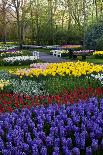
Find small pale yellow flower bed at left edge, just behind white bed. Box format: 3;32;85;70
0;50;23;58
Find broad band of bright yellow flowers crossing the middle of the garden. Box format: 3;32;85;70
10;61;103;78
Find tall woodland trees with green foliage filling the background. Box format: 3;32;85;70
0;0;103;45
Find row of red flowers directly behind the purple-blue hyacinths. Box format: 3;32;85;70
0;87;103;113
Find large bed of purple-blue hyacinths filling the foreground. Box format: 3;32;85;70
0;98;103;155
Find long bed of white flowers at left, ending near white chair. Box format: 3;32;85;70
1;56;37;65
